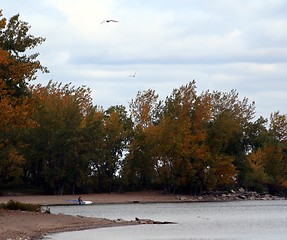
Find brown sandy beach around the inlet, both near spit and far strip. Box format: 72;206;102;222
0;191;283;240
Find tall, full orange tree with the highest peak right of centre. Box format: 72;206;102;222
156;81;214;193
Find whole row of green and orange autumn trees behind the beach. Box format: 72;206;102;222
0;11;287;194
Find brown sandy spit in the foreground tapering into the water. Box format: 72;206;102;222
0;209;138;240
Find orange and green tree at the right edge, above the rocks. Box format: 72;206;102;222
246;112;287;194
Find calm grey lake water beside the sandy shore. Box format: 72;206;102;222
45;200;287;240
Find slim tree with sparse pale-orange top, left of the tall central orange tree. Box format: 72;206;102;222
124;89;161;188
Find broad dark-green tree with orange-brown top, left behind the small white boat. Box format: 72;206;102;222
25;81;91;194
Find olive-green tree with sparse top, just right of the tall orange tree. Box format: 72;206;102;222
208;90;255;185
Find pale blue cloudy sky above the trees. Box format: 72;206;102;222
0;0;287;118
